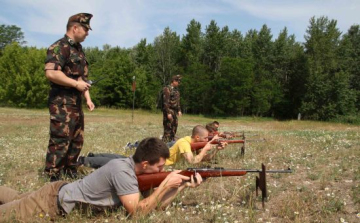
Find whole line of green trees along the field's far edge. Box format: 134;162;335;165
0;16;360;122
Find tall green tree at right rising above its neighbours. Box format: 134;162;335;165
302;17;355;120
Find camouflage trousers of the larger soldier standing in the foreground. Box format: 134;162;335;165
45;104;84;177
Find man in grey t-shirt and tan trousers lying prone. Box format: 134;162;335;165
0;138;202;222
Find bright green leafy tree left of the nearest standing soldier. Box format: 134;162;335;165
0;42;49;108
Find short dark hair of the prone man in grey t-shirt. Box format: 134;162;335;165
133;137;170;165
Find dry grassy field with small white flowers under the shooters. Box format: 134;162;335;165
0;108;360;223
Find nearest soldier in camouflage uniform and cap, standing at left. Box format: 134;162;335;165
45;13;95;181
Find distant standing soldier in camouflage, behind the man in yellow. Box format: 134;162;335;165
162;75;182;143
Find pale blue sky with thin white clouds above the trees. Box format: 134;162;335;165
0;0;360;49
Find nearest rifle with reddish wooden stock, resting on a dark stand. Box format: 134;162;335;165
137;164;292;208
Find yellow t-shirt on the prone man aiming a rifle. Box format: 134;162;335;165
165;136;192;166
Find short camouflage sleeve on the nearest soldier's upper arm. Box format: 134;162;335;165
45;41;69;70
